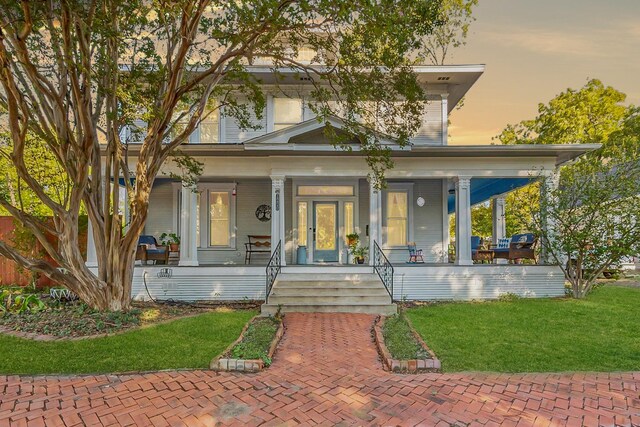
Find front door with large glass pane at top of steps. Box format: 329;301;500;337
313;202;338;262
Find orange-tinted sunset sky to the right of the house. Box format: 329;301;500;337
447;0;640;144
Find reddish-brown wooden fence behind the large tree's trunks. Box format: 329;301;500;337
0;216;87;287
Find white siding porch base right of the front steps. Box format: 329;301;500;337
393;265;564;301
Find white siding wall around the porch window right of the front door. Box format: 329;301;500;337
382;179;443;263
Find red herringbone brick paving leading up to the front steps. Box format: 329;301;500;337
0;314;640;426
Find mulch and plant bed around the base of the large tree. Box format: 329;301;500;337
0;296;260;340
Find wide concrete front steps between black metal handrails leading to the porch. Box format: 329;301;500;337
262;267;398;315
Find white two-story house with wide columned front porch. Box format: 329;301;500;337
88;65;594;312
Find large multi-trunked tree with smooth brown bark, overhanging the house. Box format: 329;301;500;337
0;0;448;310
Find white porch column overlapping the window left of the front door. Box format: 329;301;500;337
178;182;198;266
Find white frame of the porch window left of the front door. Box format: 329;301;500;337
173;182;238;251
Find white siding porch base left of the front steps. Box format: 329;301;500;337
131;266;265;301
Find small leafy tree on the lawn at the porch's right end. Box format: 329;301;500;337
520;153;640;298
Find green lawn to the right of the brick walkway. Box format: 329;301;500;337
407;286;640;372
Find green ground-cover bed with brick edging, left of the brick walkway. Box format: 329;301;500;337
231;317;280;366
